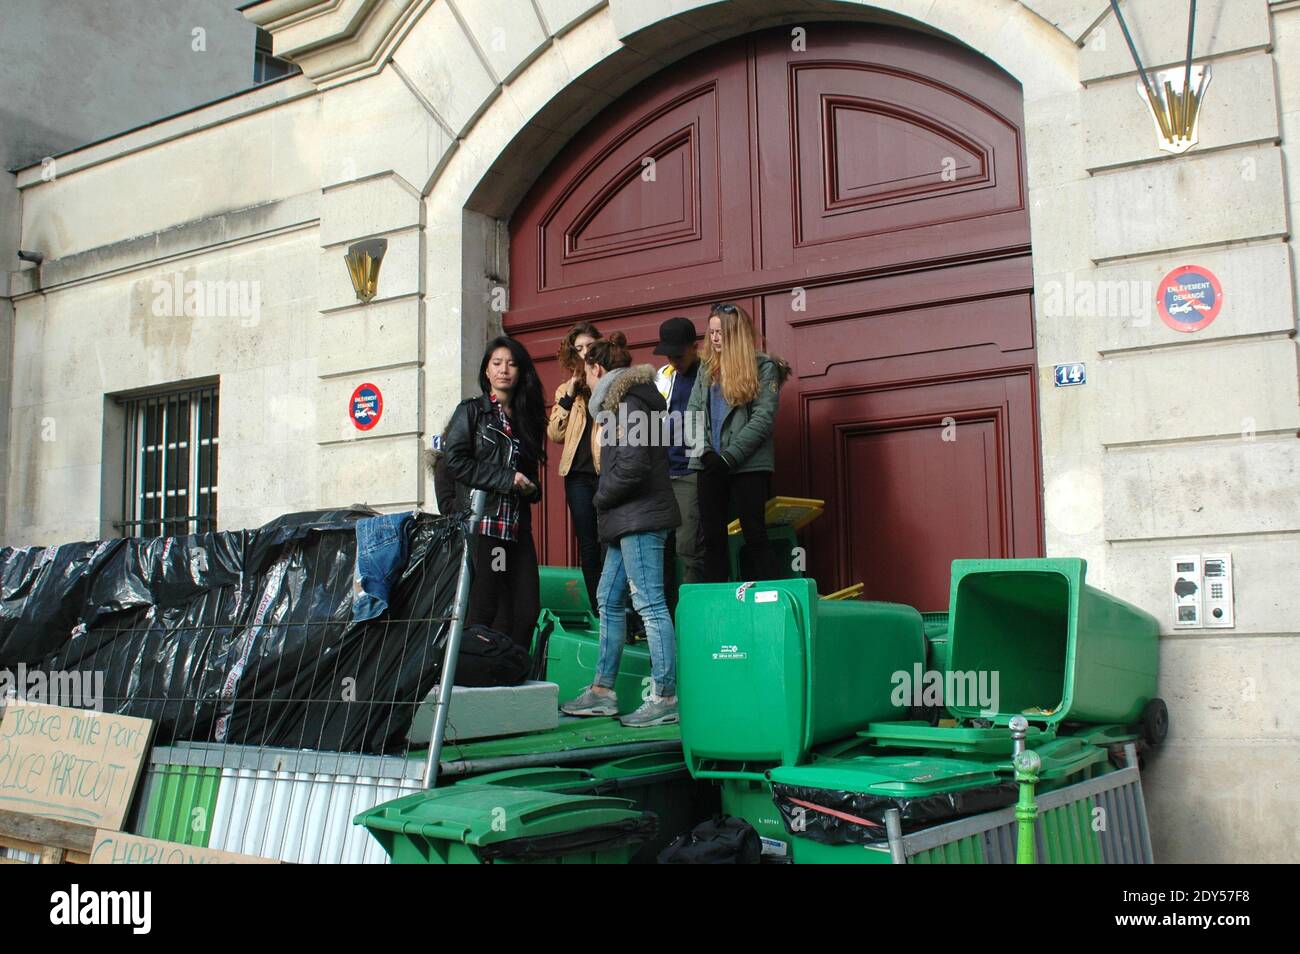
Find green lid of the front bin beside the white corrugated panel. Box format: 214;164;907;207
355;785;641;846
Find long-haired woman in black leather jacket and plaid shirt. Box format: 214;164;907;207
443;335;546;651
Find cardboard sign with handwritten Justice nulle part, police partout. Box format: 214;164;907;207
0;701;153;829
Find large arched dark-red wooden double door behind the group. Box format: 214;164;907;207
504;23;1043;610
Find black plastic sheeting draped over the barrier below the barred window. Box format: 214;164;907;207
0;508;464;753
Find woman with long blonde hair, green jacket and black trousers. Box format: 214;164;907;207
688;304;790;582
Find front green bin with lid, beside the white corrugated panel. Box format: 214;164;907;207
354;785;655;864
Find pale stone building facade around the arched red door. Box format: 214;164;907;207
4;0;1300;862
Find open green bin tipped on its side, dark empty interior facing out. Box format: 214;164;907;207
948;558;1160;725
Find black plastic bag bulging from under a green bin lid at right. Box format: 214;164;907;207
772;782;1017;845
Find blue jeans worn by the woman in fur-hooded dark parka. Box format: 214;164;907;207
595;530;677;697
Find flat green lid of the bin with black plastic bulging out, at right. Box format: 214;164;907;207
767;755;1002;798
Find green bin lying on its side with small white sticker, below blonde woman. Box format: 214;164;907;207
677;580;926;777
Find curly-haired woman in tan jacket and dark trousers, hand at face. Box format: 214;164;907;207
546;321;602;612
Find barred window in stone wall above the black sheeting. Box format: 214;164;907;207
114;385;217;537
